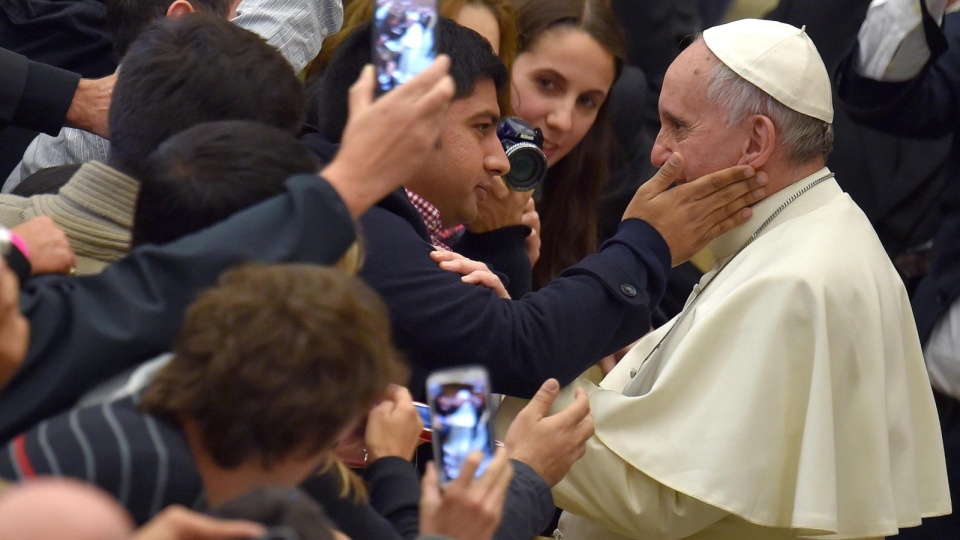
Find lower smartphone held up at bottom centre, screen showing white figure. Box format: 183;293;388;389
427;366;493;484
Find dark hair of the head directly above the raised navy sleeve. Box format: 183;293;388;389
130;120;319;246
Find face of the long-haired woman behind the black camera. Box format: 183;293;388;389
511;27;616;167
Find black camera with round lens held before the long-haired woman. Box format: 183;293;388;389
497;116;547;191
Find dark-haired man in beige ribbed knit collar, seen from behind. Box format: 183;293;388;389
0;14;304;274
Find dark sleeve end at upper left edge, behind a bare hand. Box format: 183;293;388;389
0;48;80;135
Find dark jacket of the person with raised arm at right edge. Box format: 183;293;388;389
835;13;960;341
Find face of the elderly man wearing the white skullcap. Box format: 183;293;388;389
650;40;749;183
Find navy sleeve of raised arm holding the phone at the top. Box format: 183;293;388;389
0;175;354;441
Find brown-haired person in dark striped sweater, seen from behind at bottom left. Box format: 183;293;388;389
0;265;405;523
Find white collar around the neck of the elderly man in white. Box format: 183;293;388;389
709;167;840;262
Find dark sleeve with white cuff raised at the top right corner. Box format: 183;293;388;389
835;13;960;138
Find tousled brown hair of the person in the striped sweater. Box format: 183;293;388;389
140;264;406;468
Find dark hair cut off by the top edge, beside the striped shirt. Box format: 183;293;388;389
104;0;230;60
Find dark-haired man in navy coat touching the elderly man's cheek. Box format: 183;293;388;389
304;20;757;404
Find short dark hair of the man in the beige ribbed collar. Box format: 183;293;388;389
109;13;305;177
